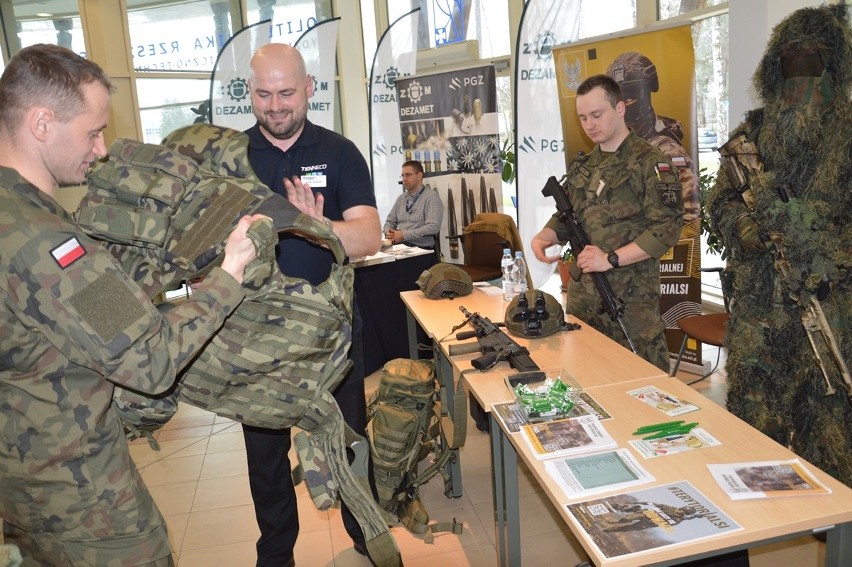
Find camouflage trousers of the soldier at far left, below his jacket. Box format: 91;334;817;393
3;522;174;567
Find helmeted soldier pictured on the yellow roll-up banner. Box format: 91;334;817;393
606;51;701;224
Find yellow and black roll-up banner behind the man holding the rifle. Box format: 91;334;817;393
554;23;702;371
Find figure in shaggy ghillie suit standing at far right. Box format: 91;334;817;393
707;5;852;486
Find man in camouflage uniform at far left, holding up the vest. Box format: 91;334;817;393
0;45;262;566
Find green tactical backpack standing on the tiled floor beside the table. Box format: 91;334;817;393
367;358;467;543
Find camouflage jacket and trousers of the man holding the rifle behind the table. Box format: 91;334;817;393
546;132;683;372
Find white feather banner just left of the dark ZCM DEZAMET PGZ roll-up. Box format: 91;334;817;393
370;8;420;223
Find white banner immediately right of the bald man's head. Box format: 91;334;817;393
295;18;340;130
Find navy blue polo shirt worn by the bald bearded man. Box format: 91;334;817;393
246;120;376;285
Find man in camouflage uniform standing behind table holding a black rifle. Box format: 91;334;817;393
531;75;683;372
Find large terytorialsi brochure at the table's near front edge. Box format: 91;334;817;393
566;481;742;558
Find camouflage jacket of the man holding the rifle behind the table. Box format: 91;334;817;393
547;132;683;301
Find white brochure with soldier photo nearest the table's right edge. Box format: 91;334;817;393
707;459;831;500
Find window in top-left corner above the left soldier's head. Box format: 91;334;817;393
0;0;86;56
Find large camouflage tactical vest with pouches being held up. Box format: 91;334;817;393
79;124;401;565
